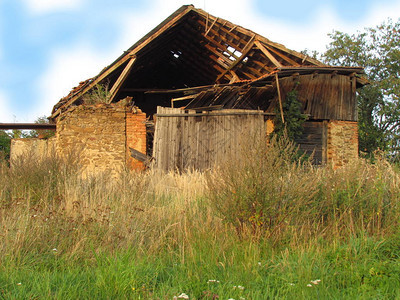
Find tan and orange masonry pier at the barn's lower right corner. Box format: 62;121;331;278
327;121;358;169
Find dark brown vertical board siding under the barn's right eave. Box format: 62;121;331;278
267;74;358;121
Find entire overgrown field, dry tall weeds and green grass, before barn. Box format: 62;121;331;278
0;142;400;300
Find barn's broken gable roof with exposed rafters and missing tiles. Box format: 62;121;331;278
51;5;365;118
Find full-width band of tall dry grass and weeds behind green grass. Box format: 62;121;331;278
0;136;400;261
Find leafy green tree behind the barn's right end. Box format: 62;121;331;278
323;19;400;156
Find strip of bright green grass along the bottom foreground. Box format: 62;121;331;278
0;238;400;299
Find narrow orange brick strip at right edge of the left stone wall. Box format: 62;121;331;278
126;109;146;170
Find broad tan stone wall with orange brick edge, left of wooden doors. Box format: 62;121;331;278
56;104;146;175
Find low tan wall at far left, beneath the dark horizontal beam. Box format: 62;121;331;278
10;137;56;162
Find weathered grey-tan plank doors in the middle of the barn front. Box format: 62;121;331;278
153;107;265;171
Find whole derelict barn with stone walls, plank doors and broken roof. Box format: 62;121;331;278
12;5;366;171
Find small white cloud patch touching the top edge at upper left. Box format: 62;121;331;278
23;0;84;14
